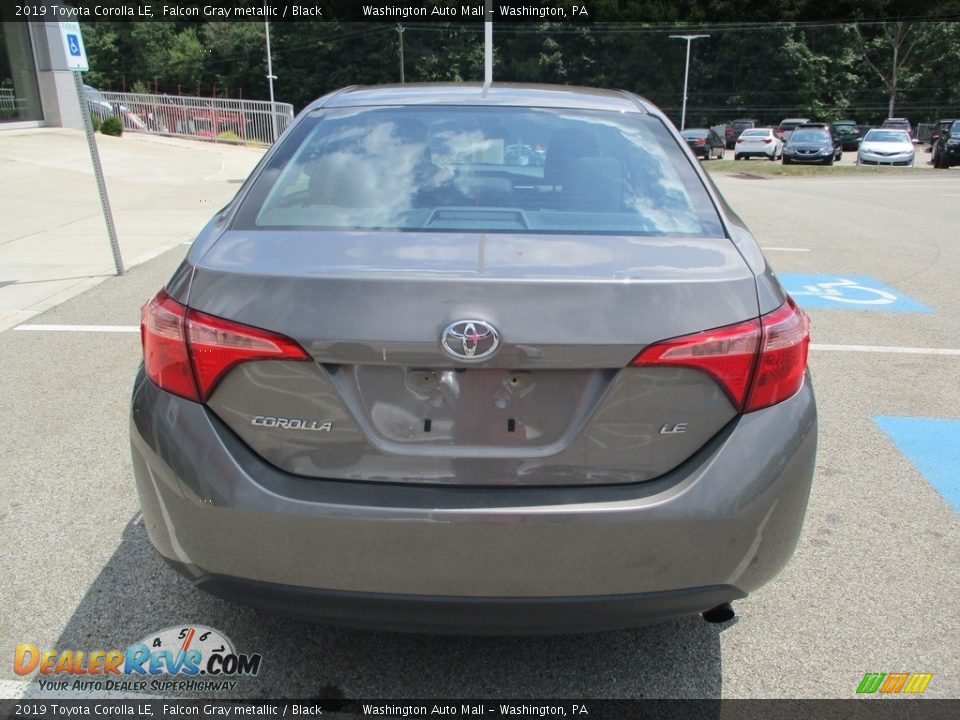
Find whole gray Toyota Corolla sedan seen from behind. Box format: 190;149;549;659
131;85;817;632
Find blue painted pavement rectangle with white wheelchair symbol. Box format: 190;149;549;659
777;273;933;312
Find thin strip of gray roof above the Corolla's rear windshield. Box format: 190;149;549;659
307;83;661;116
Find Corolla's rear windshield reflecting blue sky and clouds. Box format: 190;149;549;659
234;106;723;237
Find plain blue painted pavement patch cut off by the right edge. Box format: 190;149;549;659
873;415;960;513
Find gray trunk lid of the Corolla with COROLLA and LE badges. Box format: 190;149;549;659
189;231;758;485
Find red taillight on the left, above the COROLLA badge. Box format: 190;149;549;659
140;290;309;402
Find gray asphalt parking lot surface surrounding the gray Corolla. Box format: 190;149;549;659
0;162;960;698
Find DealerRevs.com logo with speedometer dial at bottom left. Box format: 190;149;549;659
13;625;263;692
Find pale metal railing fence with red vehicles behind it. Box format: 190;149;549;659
86;89;293;145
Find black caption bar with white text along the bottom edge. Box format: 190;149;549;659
0;698;960;720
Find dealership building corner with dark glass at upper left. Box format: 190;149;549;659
0;13;83;130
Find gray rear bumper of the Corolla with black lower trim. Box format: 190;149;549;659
131;372;816;632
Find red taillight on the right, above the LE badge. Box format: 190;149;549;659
630;298;810;412
